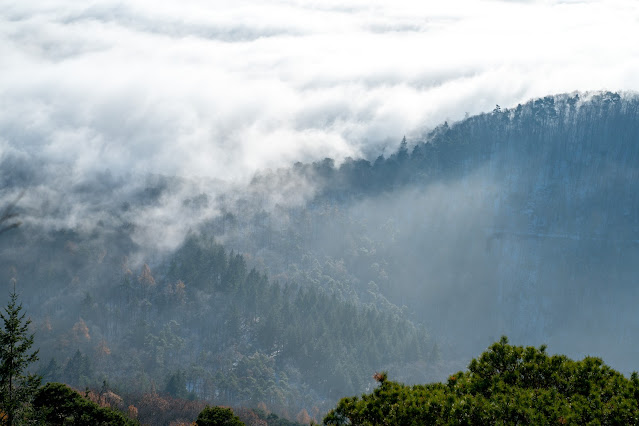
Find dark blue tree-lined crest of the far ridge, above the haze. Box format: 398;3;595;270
296;92;639;200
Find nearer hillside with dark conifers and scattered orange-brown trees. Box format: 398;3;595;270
3;228;435;422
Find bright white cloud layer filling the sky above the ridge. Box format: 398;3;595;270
0;0;639;179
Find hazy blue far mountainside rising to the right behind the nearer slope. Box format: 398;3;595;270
216;93;639;373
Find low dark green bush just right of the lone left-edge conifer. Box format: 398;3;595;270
33;383;138;426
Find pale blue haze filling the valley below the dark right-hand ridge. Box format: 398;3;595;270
336;165;639;372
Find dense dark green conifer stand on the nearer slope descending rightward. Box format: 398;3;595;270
159;235;432;404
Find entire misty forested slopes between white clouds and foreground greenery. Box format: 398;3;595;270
0;93;639;424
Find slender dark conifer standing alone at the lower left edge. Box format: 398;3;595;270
0;287;42;425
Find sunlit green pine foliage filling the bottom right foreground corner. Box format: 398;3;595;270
324;337;639;425
